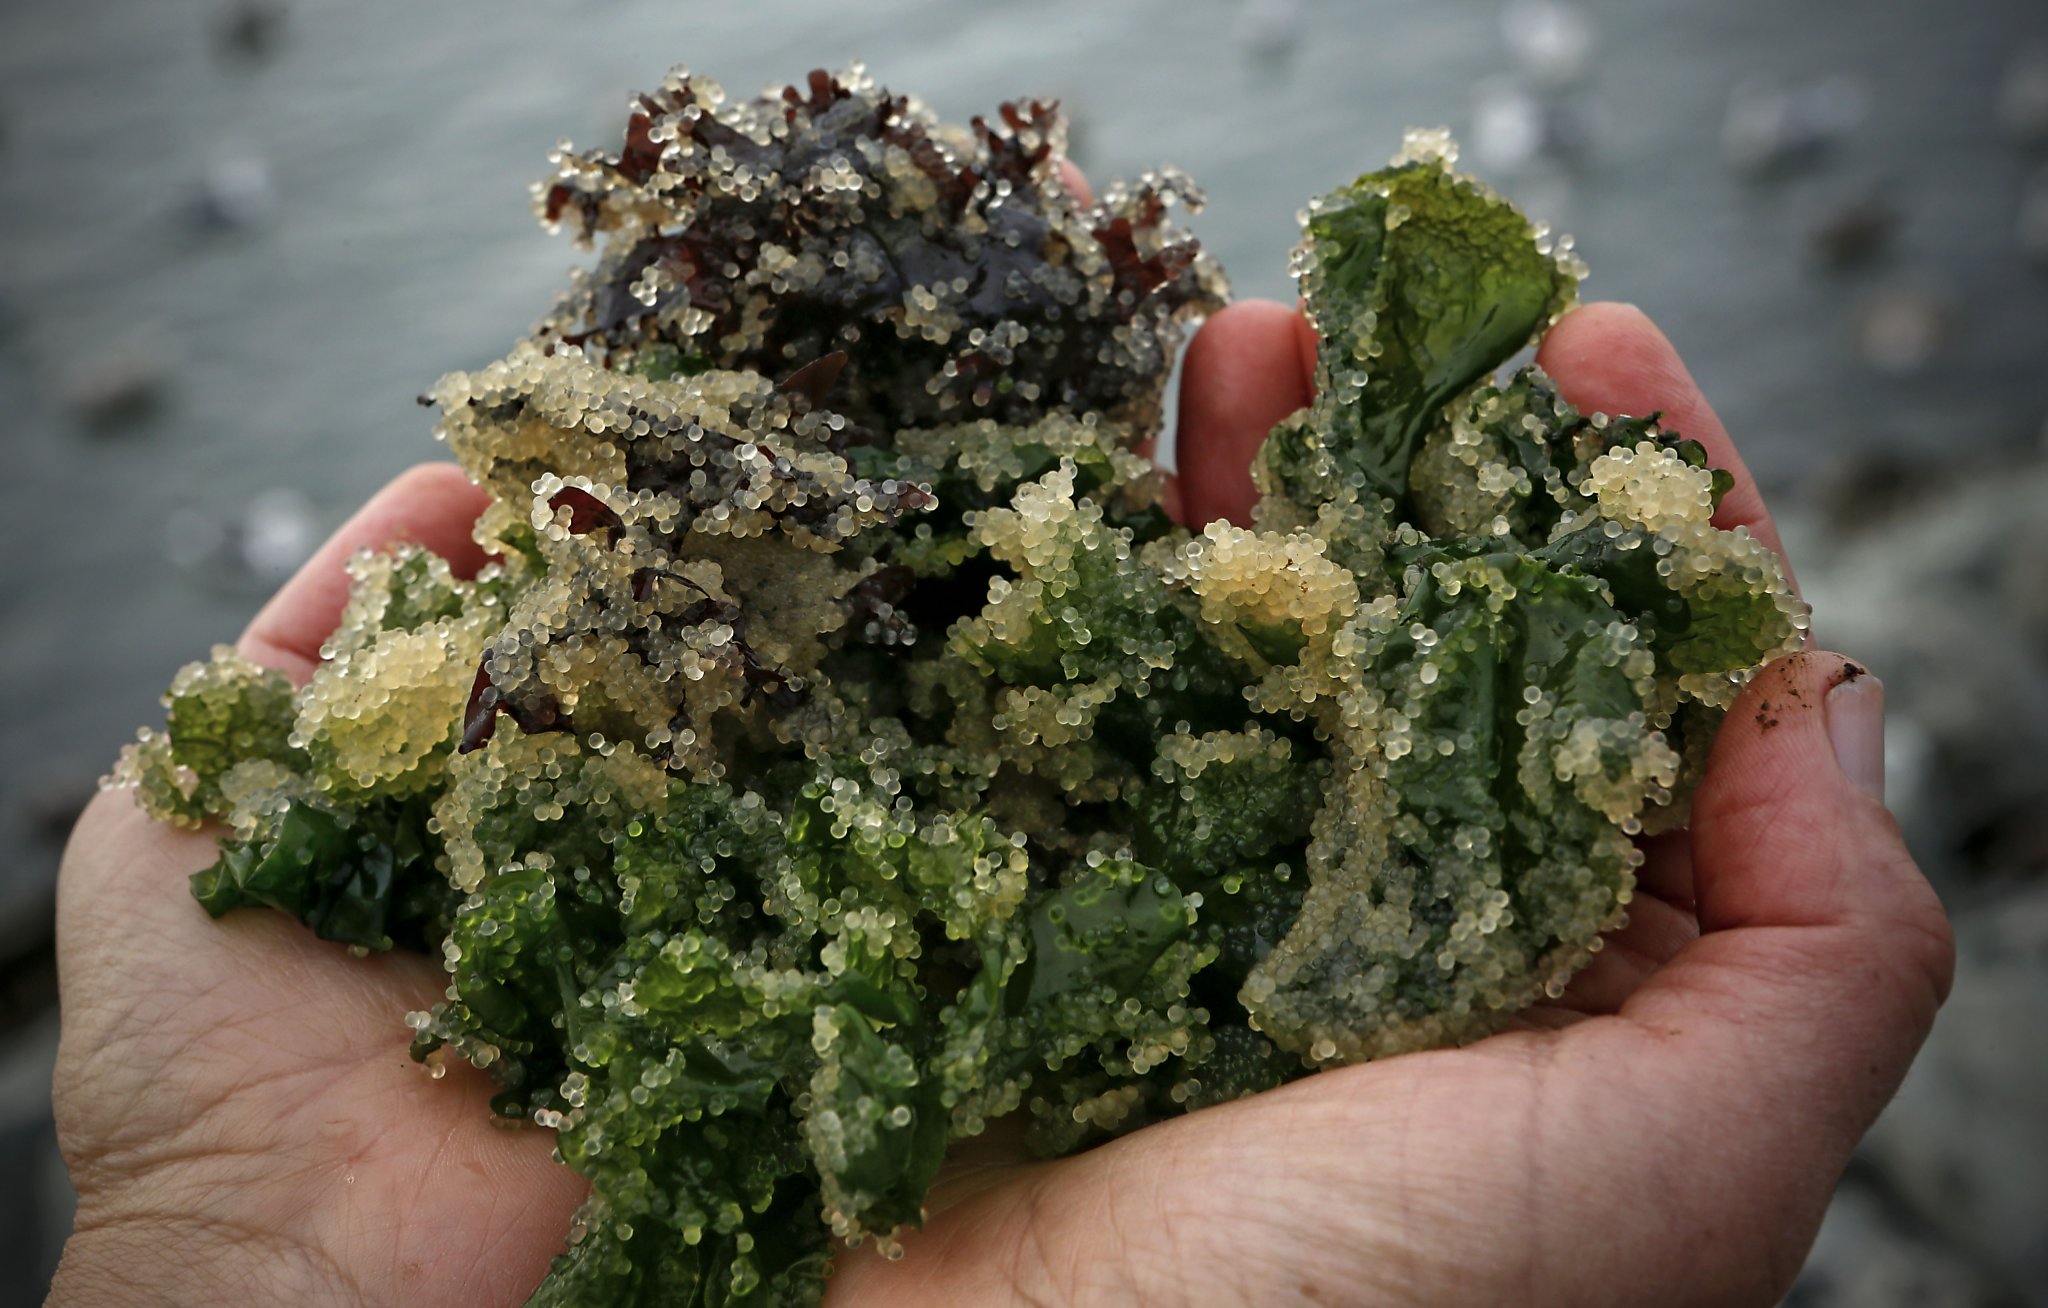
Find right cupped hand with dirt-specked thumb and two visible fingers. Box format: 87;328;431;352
831;303;1954;1308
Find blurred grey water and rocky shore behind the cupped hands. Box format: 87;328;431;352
0;0;2048;1306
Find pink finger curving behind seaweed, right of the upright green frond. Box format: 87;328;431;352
1536;303;1786;577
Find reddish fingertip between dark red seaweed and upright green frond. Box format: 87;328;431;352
1174;299;1315;526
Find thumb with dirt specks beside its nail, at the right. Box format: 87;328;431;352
1622;653;1956;1175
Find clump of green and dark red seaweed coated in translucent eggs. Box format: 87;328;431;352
115;70;1806;1304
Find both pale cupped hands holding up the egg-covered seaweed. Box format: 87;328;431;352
51;301;1954;1308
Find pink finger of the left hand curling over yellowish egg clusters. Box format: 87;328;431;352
238;463;489;682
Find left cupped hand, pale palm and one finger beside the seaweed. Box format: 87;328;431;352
51;465;584;1306
